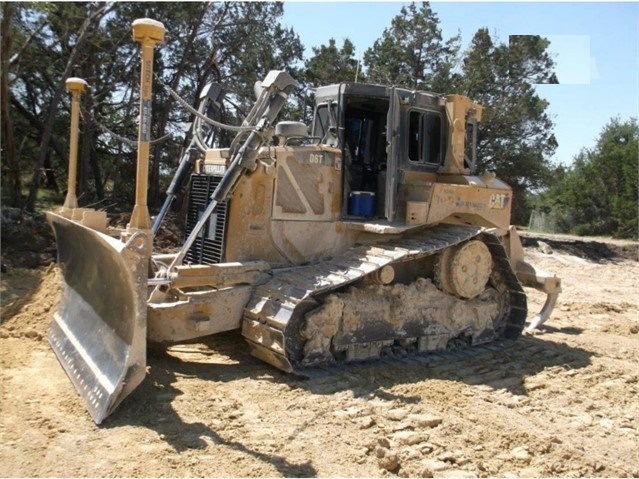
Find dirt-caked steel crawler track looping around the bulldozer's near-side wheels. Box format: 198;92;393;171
242;226;527;375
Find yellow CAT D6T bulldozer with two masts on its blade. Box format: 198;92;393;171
47;19;561;424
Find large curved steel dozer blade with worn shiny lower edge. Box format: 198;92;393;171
47;213;150;424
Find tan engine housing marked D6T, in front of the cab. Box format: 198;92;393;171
225;146;347;265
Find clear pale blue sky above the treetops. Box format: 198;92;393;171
282;1;639;165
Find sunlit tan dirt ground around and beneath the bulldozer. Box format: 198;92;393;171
0;227;639;477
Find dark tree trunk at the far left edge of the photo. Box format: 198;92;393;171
0;2;22;208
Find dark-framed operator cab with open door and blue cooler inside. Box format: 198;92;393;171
312;83;447;223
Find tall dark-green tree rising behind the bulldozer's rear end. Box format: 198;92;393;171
459;28;557;224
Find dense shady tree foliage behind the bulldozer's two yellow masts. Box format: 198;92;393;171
2;2;303;207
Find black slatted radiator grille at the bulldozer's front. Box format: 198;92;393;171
186;174;228;264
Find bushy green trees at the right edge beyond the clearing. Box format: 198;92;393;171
540;118;639;238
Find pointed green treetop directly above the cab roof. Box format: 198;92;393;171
364;2;461;92
